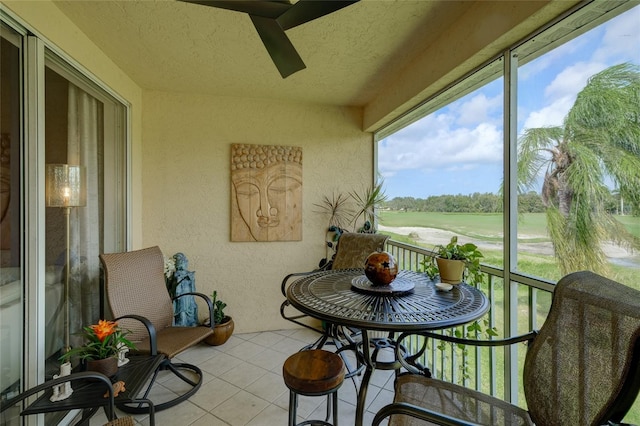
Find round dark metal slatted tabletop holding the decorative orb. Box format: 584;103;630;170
287;269;489;331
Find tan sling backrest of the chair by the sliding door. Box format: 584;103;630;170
100;246;173;342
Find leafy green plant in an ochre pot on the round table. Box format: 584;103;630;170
423;235;484;284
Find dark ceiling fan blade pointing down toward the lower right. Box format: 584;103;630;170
249;15;307;78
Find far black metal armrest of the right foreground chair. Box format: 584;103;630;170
395;331;538;377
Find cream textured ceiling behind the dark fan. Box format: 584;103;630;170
55;0;474;106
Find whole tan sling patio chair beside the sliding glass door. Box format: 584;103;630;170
100;247;214;413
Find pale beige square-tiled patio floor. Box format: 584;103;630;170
85;329;393;426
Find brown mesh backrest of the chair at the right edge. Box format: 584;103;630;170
523;271;640;426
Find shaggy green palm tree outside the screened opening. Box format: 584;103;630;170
518;63;640;274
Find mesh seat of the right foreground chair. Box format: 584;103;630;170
389;374;533;426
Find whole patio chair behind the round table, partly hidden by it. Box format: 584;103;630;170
280;232;389;377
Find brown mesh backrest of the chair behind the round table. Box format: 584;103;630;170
331;232;389;269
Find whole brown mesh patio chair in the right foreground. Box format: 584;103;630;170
373;272;640;426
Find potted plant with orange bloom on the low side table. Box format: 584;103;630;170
60;320;135;376
